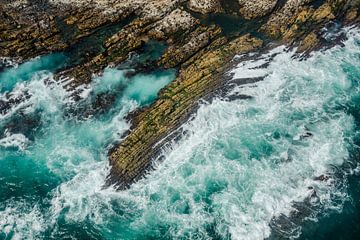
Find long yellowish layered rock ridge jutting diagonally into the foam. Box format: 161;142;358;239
110;35;262;189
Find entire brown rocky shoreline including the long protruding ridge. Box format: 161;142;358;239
0;0;360;189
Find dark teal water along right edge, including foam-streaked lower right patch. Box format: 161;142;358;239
268;66;360;240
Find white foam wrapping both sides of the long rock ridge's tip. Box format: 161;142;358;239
0;27;359;240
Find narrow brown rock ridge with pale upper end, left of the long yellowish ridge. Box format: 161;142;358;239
56;9;201;89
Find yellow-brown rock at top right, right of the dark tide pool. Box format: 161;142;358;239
261;0;359;47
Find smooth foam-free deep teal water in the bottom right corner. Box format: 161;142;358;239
299;93;360;240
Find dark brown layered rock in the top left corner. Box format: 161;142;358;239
0;0;67;59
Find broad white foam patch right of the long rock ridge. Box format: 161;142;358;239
117;27;359;239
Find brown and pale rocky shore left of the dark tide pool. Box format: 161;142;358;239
0;0;222;89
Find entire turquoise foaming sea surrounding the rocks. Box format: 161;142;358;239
0;29;360;240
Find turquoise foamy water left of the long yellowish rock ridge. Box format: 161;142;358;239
0;61;175;238
